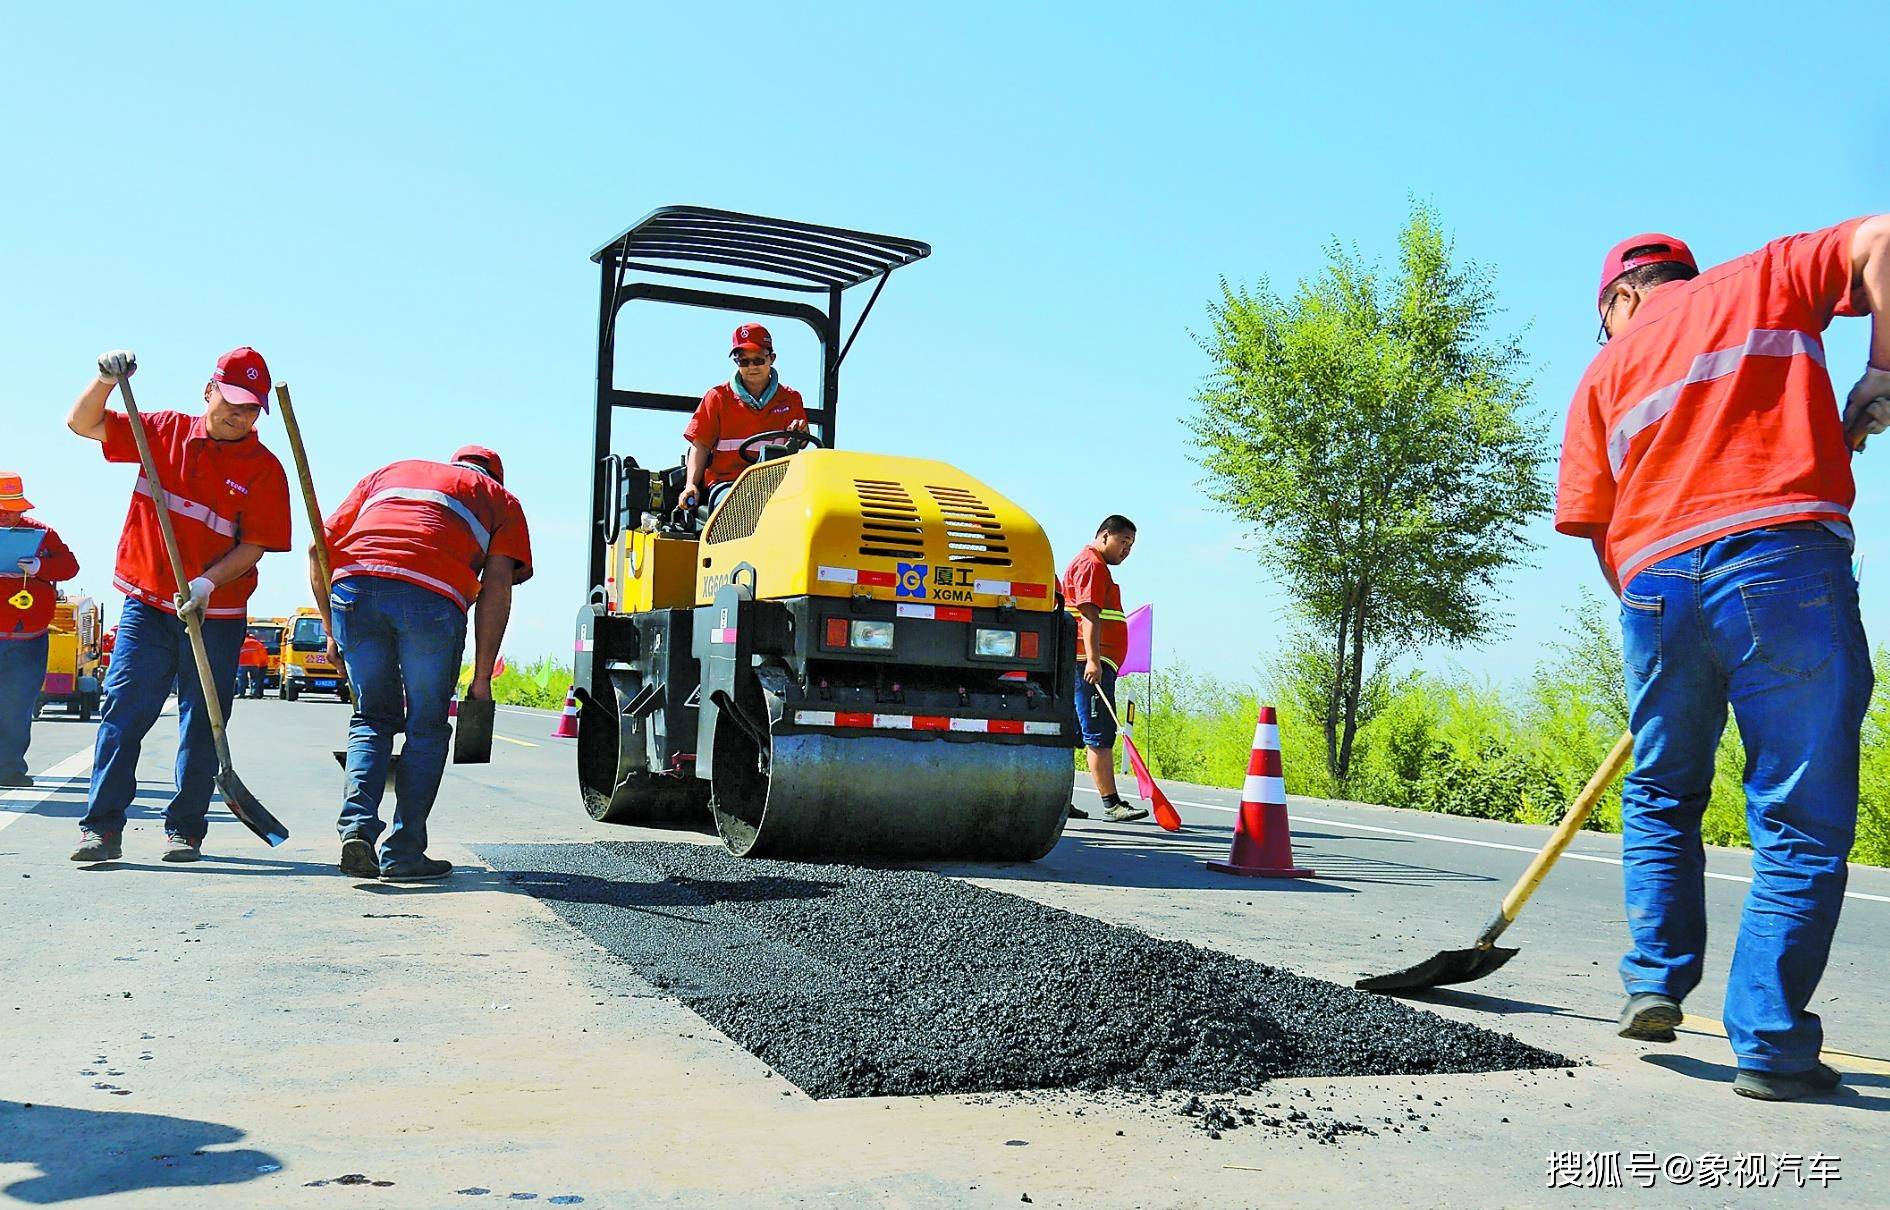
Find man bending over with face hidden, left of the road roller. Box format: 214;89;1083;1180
308;446;531;883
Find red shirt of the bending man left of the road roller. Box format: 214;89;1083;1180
321;458;531;609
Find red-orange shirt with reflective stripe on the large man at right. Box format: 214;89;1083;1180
1555;219;1864;584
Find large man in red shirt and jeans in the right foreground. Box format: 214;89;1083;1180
1555;216;1890;1100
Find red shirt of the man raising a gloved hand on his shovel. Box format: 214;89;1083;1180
104;410;289;618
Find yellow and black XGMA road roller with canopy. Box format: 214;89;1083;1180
575;206;1079;860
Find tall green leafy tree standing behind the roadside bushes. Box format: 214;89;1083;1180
1189;204;1550;787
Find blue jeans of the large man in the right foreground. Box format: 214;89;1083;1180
1622;529;1875;1072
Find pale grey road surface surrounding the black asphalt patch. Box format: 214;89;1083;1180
0;698;1890;1206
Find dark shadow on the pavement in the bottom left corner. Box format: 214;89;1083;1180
0;1100;282;1206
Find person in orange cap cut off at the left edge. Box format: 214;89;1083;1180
0;471;79;787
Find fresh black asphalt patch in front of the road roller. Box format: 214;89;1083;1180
480;841;1569;1097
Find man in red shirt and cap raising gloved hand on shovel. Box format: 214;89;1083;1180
66;346;289;862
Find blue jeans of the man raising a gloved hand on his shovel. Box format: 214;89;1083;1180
79;597;248;843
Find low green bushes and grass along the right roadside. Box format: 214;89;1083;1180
1125;596;1890;866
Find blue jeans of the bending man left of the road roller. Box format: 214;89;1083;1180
329;575;467;870
